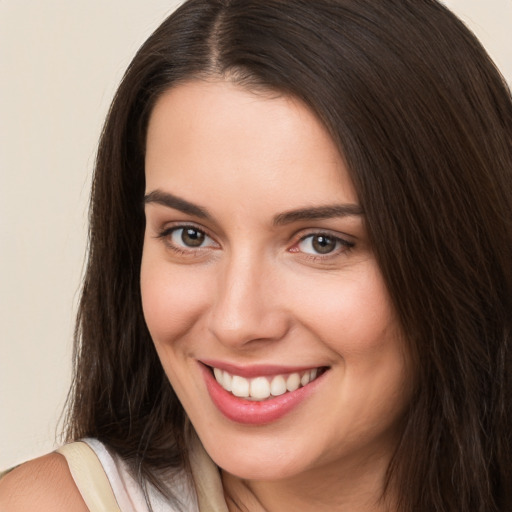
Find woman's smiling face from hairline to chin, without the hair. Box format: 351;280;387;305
141;81;410;479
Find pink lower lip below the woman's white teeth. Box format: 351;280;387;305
199;363;325;425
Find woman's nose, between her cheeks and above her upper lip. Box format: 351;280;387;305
209;251;290;348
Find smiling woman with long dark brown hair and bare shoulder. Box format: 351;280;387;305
0;0;512;512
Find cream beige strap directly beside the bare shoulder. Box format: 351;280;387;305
57;441;121;512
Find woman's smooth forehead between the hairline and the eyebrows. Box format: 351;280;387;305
146;81;357;209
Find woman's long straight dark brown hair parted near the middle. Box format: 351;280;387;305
67;0;512;512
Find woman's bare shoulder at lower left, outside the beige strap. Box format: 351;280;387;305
0;453;89;512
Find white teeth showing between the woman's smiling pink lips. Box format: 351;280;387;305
211;367;327;402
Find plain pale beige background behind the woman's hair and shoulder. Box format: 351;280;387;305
0;0;512;468
